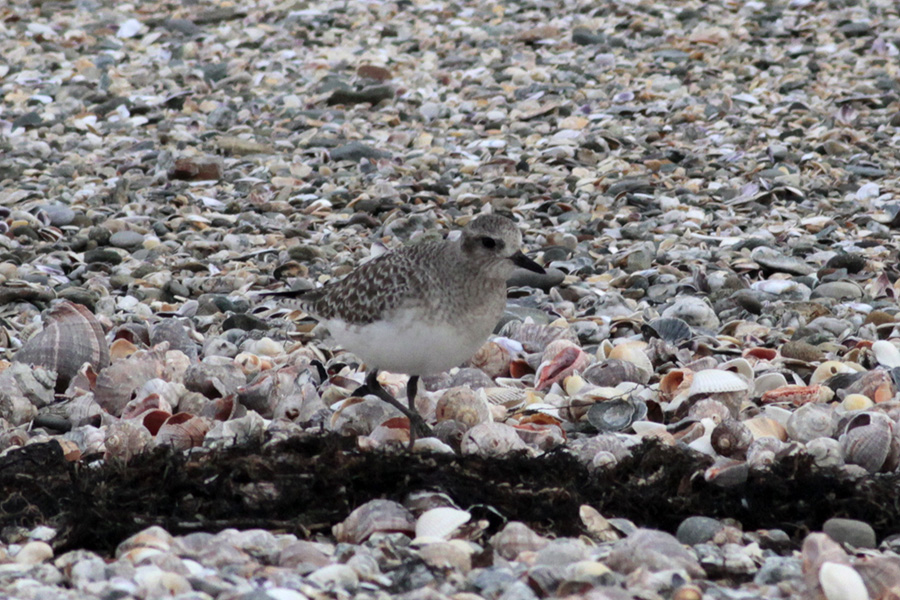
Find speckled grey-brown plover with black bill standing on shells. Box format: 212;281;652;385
266;215;544;445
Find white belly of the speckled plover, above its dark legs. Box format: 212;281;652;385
325;314;496;375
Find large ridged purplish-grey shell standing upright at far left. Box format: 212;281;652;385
13;301;109;392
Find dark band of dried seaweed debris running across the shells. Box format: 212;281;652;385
0;435;900;553
